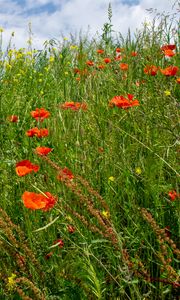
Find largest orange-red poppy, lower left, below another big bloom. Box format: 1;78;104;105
22;191;57;211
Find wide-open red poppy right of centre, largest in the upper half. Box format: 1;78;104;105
109;94;140;109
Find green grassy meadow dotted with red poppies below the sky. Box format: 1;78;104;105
0;7;180;300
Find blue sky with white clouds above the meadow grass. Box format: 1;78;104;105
0;0;178;49
